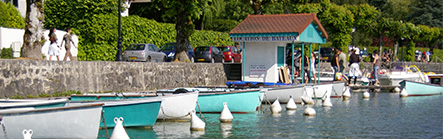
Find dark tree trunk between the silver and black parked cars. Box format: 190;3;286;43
174;0;194;62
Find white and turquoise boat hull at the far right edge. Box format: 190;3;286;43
400;80;443;96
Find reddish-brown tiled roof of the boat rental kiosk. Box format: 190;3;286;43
229;13;328;39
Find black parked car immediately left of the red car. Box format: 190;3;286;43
194;46;225;63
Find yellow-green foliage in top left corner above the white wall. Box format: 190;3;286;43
0;1;25;29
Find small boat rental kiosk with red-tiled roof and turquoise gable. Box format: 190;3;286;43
229;13;328;83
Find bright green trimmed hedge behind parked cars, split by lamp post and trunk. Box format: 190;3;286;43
78;15;234;61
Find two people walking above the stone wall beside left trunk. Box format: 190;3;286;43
48;28;77;61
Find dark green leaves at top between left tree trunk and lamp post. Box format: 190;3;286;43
44;0;118;29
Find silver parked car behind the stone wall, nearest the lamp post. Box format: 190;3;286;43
123;44;166;62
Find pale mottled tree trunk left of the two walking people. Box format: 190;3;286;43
21;0;45;59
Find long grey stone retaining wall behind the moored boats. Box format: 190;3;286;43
0;60;226;98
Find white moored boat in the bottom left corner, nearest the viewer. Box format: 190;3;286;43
0;104;103;139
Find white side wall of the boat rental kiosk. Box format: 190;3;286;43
243;42;286;83
